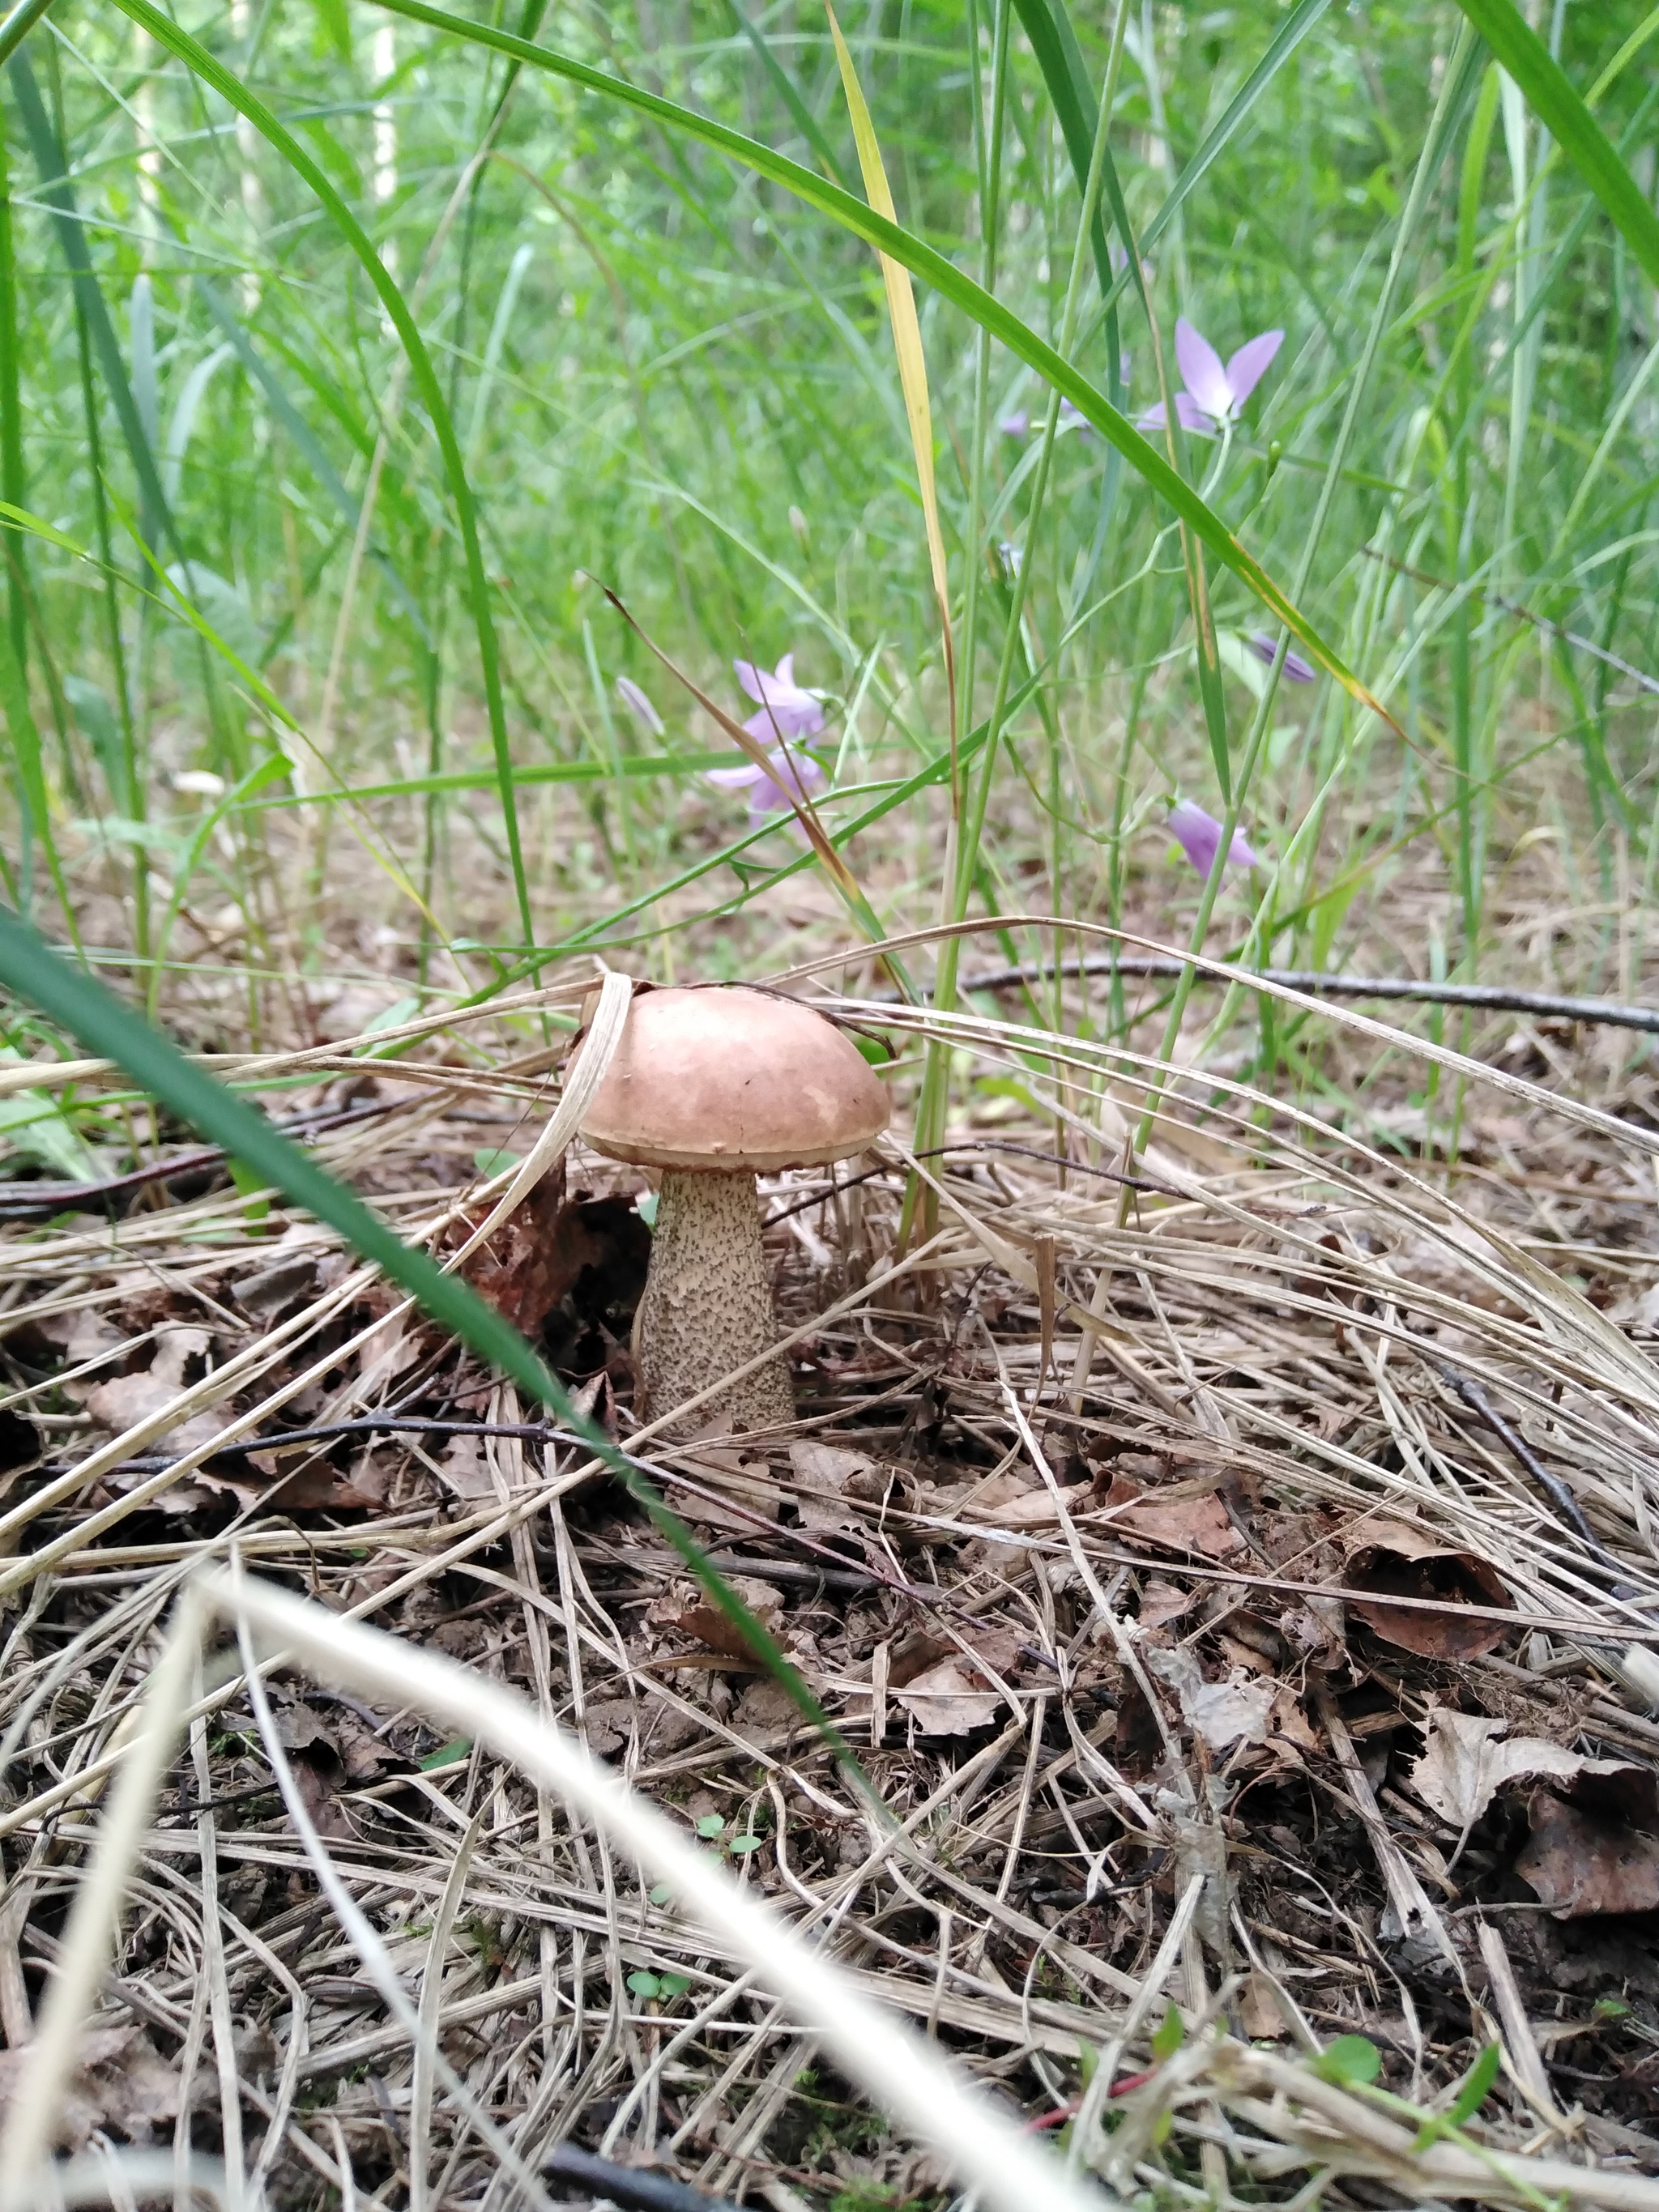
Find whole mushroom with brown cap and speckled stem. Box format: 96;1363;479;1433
582;984;887;1434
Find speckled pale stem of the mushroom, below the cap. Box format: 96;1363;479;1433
635;1168;794;1435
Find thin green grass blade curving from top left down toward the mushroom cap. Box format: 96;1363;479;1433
107;0;535;944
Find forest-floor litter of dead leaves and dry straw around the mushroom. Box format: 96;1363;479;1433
0;969;1659;2208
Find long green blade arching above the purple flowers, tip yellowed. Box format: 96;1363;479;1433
369;0;1393;726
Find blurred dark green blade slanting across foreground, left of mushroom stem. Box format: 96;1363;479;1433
0;906;874;1801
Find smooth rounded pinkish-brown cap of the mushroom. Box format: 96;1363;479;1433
582;984;887;1174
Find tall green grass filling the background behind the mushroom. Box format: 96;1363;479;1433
0;0;1659;1084
